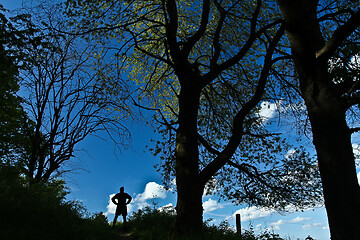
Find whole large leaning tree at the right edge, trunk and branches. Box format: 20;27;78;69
277;0;360;239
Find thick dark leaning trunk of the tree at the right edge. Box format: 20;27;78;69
278;0;360;240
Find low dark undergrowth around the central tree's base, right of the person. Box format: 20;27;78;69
127;207;282;240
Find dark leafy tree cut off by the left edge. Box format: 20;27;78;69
0;5;36;164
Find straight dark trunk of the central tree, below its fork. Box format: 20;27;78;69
175;82;204;235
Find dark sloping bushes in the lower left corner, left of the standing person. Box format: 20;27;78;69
0;165;121;240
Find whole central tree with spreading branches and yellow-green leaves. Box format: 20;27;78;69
67;0;321;235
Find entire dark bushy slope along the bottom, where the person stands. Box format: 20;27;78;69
0;166;281;240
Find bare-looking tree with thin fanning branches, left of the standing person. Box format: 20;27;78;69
16;2;129;182
